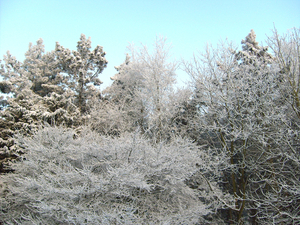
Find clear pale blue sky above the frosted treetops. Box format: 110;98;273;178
0;0;300;87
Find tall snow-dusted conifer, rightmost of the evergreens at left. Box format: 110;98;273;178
55;34;108;114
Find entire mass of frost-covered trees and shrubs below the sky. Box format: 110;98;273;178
0;28;300;224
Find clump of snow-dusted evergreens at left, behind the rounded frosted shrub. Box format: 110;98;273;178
0;35;107;172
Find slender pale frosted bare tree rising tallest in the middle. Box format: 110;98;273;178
132;37;177;142
